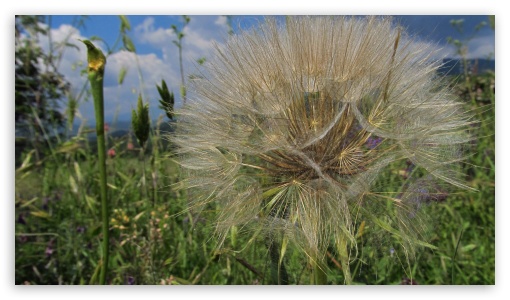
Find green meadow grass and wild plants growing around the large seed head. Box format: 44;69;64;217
15;15;495;285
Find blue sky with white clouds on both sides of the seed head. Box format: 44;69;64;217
31;15;495;124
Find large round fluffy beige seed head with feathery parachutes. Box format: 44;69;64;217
172;17;472;259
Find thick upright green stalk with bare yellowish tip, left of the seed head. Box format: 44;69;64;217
83;40;109;284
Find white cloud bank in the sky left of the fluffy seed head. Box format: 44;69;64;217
31;18;218;121
